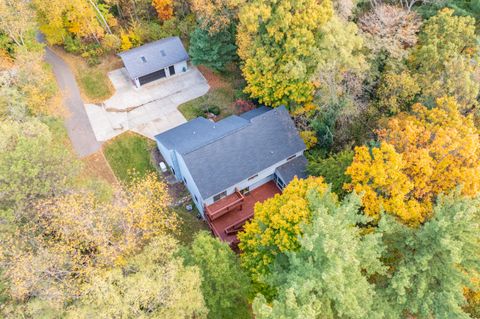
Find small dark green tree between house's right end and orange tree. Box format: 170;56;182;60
307;151;353;198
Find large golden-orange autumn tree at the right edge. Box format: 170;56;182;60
344;98;480;226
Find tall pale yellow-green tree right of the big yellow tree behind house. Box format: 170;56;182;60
310;16;368;149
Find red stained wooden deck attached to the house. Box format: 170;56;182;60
205;181;281;246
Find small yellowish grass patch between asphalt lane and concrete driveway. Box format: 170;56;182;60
78;67;112;101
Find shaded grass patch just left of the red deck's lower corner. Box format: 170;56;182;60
175;202;210;245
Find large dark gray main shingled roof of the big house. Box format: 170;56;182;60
183;106;305;199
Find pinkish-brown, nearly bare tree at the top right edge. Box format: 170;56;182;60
358;4;422;59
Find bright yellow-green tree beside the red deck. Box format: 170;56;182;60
238;177;327;294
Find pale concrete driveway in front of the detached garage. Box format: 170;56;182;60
85;67;210;141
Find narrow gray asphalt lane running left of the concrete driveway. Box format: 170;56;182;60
45;47;101;157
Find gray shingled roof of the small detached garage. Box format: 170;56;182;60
118;37;189;79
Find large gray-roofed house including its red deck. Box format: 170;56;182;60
155;106;307;244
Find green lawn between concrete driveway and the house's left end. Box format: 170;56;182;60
104;132;155;182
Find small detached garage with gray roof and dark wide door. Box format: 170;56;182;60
118;37;189;88
